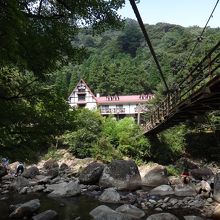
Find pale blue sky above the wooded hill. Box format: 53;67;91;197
118;0;220;27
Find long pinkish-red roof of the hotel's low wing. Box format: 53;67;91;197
96;94;154;105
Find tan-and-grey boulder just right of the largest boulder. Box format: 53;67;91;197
140;164;168;187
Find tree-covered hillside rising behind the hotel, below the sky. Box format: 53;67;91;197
56;19;220;97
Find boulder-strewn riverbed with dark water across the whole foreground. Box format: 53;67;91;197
0;152;220;220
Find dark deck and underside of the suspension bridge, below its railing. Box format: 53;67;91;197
145;75;220;134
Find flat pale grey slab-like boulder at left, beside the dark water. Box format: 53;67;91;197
48;181;81;197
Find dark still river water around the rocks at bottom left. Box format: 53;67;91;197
0;193;106;220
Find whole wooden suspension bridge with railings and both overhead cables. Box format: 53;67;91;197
129;0;220;134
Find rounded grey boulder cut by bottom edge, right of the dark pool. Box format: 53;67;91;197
89;205;134;220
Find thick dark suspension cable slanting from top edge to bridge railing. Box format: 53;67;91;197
129;0;169;93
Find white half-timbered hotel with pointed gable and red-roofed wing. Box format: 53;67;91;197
68;79;154;118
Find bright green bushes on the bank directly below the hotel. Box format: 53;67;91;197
63;112;150;162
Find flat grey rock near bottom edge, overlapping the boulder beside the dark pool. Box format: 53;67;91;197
115;204;145;219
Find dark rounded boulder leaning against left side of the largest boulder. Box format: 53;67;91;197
79;162;104;185
